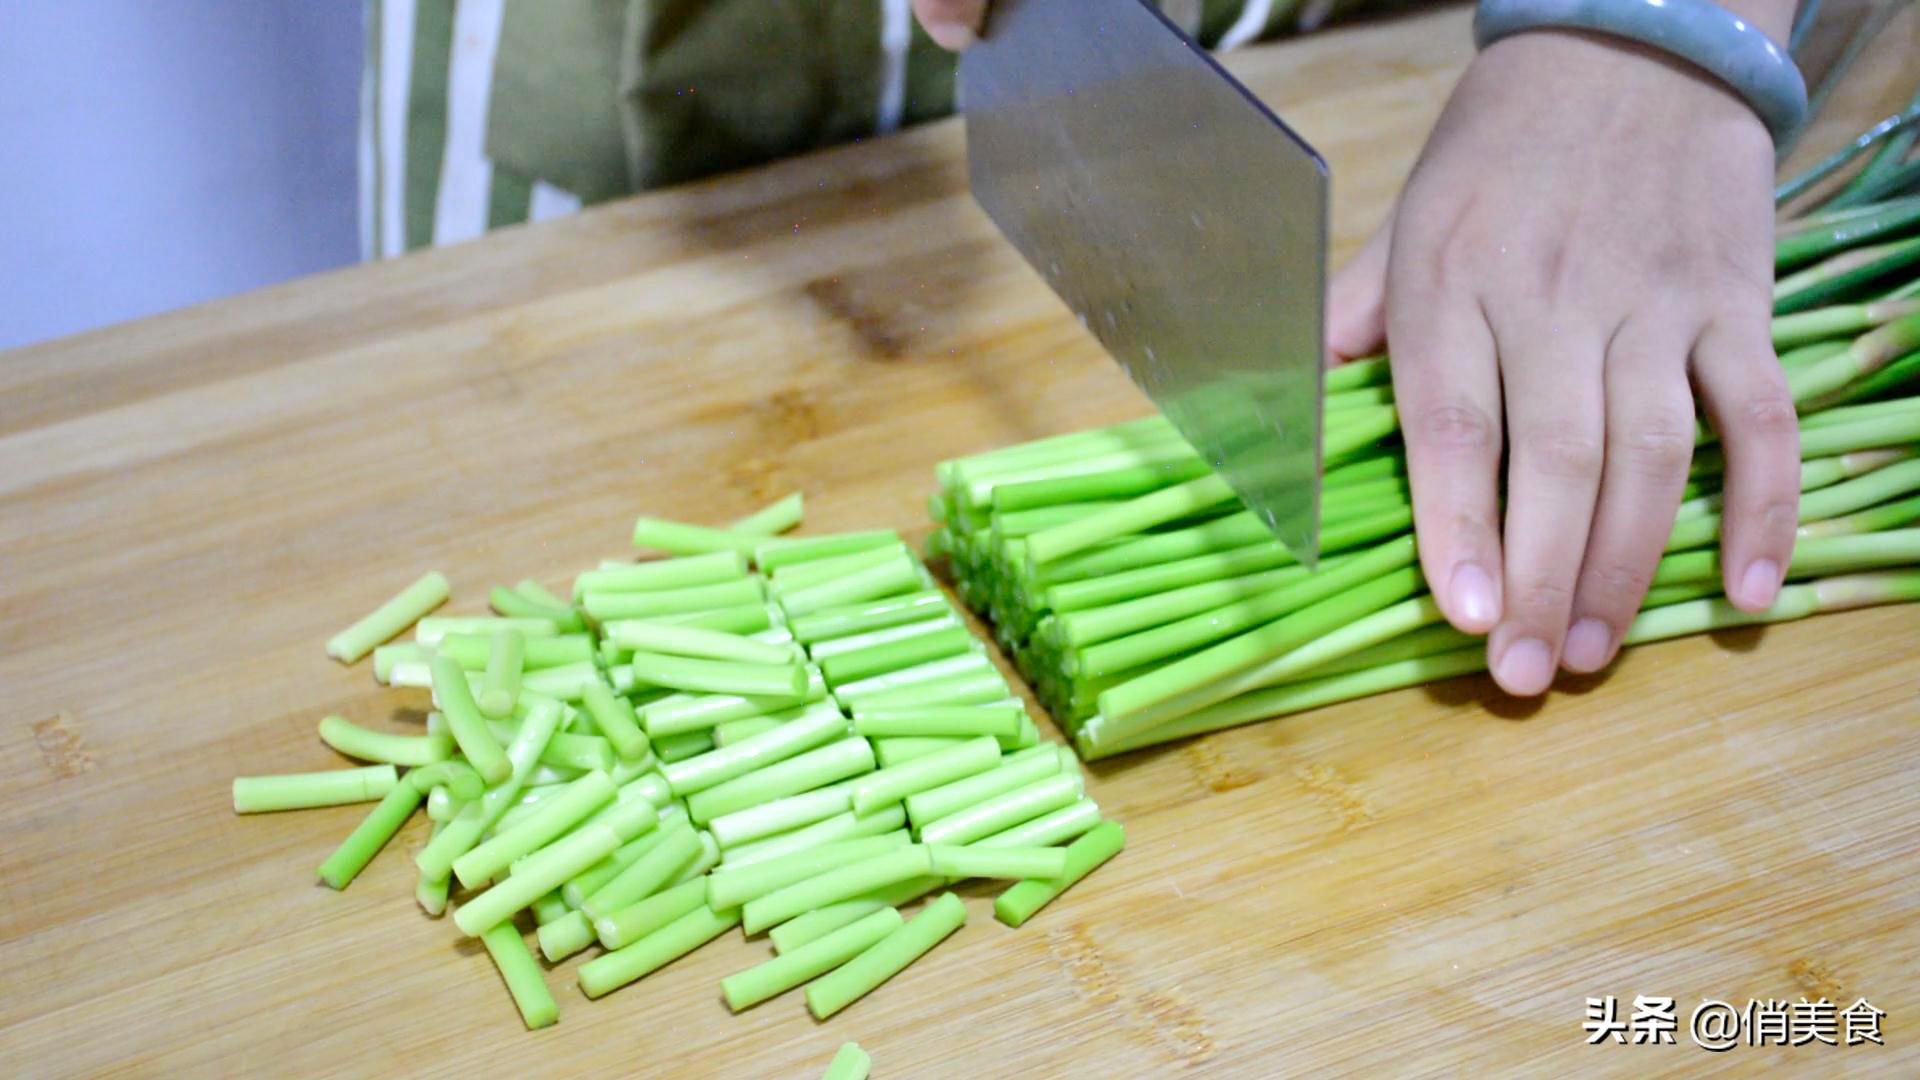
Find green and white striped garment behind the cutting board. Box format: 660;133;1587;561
365;0;1419;248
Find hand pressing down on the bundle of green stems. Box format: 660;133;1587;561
1329;33;1799;696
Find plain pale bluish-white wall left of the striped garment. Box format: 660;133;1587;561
0;0;361;350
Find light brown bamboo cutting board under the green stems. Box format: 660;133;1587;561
0;10;1920;1078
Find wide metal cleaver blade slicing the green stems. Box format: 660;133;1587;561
960;0;1327;567
